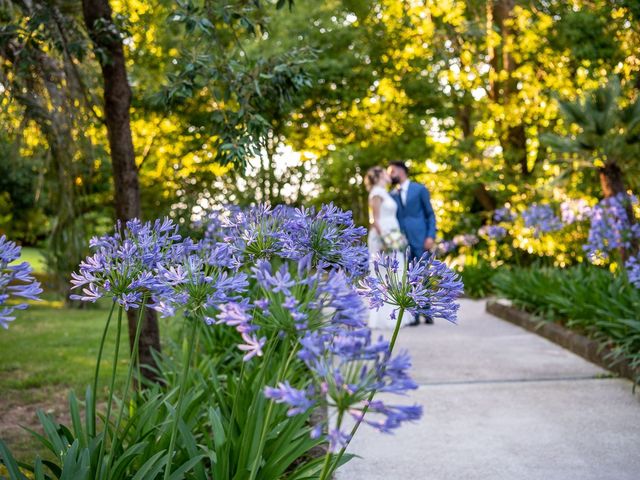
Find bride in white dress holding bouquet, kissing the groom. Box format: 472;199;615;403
364;167;408;329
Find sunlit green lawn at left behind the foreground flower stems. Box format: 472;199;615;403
0;302;129;460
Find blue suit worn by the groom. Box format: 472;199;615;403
391;182;436;260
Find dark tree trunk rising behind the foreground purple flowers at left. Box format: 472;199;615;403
82;0;160;381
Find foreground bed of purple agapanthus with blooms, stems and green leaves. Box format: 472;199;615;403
0;205;462;480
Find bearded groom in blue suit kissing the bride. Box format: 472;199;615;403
387;161;436;325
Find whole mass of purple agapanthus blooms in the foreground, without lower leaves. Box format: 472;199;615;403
73;205;464;458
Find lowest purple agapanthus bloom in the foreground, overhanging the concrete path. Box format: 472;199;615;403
265;328;422;451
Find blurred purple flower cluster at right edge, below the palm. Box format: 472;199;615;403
584;193;640;261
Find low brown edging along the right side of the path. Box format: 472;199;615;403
486;299;640;382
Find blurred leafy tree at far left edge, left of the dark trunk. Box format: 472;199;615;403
0;2;91;298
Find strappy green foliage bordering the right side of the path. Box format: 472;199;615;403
493;265;640;380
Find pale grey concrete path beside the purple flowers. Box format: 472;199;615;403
337;300;640;480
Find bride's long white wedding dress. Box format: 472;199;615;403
368;185;410;329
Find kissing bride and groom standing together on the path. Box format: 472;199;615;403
364;161;436;329
